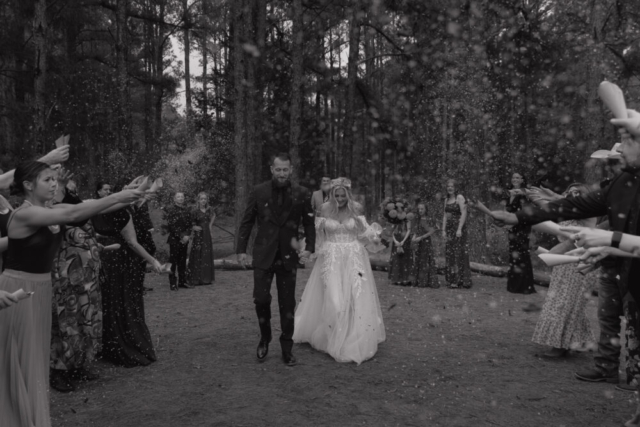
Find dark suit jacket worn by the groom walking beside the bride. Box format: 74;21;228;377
236;181;316;270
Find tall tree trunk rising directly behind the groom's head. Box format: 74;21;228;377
289;0;304;179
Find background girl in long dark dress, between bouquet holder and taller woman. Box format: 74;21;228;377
411;203;440;288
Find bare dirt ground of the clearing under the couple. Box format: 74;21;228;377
51;260;635;427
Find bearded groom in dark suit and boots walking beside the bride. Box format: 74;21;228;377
236;153;316;366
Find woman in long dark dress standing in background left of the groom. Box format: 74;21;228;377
188;192;216;286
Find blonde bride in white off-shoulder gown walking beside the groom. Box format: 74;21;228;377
293;178;385;364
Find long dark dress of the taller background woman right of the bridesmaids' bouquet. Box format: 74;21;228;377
444;202;472;288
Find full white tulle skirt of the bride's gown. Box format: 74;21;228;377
293;241;385;364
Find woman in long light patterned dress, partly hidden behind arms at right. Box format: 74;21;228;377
532;184;598;358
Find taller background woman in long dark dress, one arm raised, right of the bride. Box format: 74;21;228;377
442;180;472;289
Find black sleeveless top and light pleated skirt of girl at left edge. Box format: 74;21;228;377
0;206;62;427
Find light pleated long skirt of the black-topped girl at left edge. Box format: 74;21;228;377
0;270;52;427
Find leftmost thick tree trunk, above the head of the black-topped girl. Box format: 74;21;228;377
32;0;48;153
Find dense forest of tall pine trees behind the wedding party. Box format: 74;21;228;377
0;0;640;260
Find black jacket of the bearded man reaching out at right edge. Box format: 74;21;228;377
516;172;640;302
